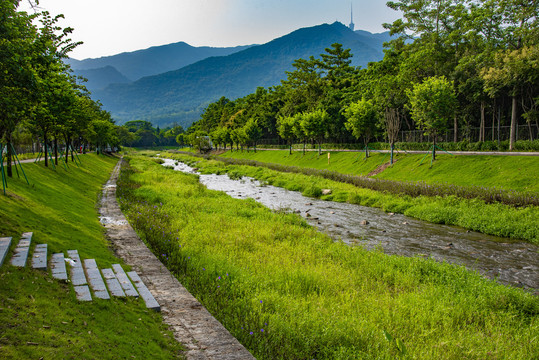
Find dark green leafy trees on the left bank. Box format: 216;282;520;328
0;0;119;176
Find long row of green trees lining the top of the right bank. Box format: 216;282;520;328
186;0;539;159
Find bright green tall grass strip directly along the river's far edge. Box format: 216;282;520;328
170;154;539;244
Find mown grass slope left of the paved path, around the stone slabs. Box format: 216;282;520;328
0;155;180;359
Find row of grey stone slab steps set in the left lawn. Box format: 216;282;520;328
0;232;160;311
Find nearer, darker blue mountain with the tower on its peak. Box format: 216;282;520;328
94;22;388;128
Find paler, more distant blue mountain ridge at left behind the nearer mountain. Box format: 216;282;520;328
66;42;253;81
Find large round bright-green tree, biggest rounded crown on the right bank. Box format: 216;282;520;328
408;77;456;160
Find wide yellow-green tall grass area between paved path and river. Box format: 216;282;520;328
118;156;539;359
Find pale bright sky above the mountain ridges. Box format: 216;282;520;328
20;0;399;60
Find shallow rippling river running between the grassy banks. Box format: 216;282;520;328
163;159;539;290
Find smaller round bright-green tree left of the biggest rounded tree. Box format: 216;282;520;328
344;98;379;157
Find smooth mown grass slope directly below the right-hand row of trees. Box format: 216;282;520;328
221;150;539;193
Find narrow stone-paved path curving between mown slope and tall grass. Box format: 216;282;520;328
99;159;254;360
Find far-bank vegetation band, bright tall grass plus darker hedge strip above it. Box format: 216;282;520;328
167;150;539;243
